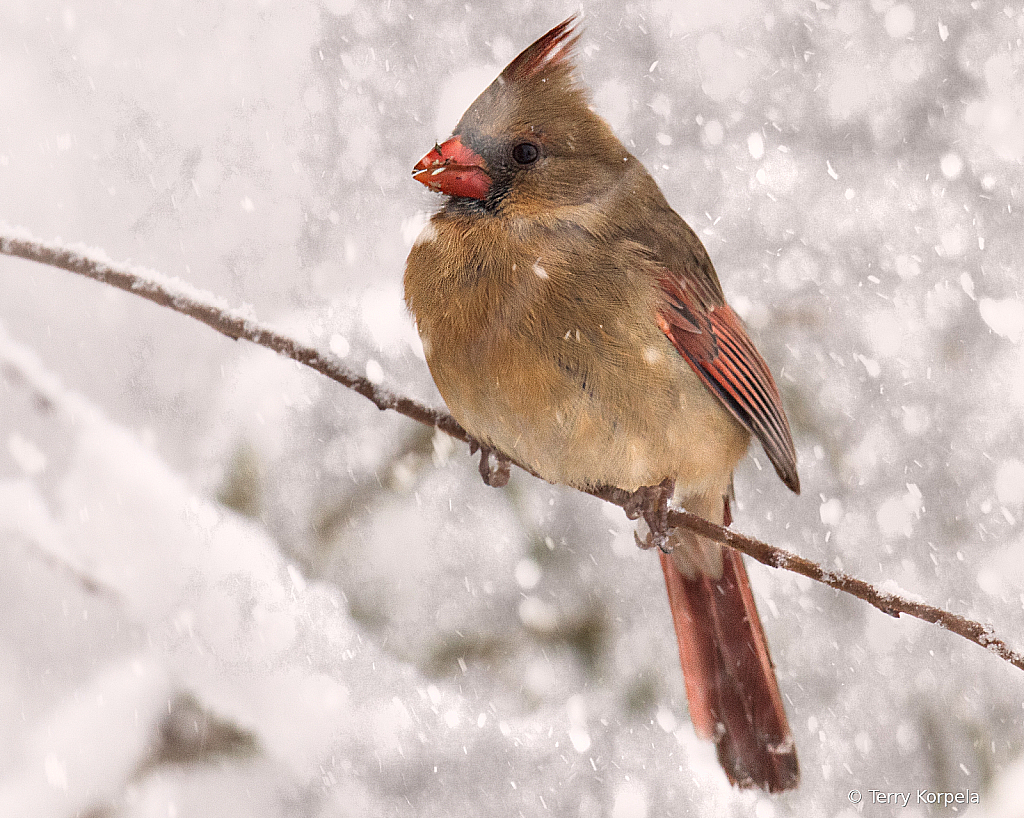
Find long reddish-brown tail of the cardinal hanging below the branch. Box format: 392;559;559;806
660;548;800;792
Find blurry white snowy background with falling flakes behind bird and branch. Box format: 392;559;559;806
0;0;1024;818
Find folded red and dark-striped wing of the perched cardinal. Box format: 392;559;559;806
657;273;800;493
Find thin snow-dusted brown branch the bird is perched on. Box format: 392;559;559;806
0;225;1024;670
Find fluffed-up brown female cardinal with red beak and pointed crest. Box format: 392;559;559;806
406;17;799;791
